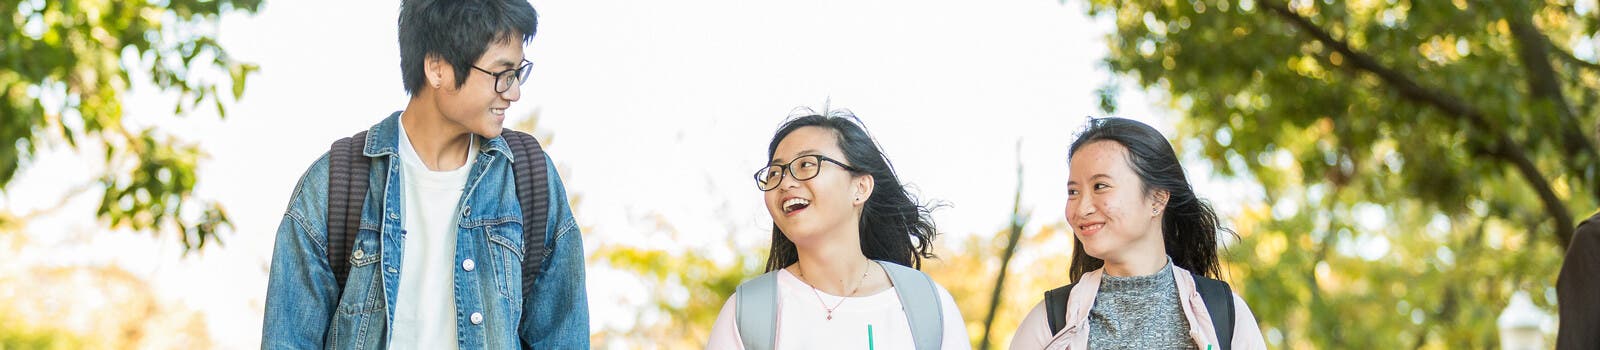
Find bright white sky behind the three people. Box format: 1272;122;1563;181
6;0;1260;348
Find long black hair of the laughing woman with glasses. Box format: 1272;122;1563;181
766;107;938;272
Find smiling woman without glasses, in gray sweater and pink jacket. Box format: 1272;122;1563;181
1011;118;1266;350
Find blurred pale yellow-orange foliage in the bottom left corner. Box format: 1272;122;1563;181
0;232;216;350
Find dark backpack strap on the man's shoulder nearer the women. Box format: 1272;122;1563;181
501;129;550;296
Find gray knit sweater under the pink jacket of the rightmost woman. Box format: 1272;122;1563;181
1090;261;1198;348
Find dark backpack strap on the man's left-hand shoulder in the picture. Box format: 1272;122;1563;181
328;131;371;289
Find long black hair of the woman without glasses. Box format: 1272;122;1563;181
1067;118;1237;281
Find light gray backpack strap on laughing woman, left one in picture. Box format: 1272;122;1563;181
733;272;778;350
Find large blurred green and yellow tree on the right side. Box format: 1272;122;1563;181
1088;0;1580;348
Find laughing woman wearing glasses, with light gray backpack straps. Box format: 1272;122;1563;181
706;107;971;348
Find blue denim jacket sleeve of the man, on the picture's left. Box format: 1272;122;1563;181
261;155;338;348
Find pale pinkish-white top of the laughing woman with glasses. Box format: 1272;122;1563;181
706;270;973;350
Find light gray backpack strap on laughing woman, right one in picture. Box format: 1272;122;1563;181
878;261;944;350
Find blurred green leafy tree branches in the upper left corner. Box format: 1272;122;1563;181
0;0;261;251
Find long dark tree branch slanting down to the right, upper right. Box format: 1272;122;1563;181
1258;0;1574;249
